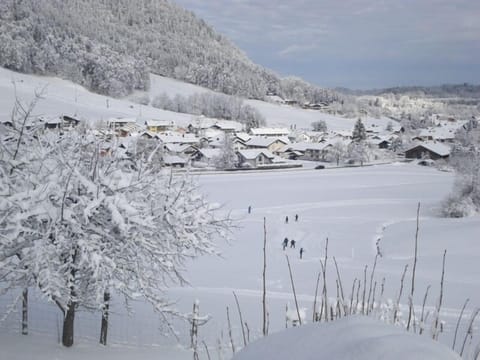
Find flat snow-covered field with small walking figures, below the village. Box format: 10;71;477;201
0;164;480;359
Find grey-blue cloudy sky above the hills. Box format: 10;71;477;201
174;0;480;88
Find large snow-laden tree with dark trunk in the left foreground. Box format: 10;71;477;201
0;107;229;346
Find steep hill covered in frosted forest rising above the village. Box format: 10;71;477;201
0;0;339;102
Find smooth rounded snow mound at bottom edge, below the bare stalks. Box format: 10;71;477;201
233;317;460;360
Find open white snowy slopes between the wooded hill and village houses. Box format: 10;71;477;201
0;68;388;131
